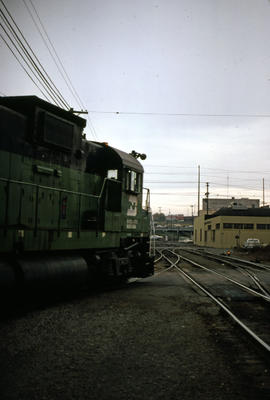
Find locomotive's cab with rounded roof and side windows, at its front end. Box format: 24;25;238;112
86;142;148;236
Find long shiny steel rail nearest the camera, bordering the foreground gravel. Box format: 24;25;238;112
160;249;270;353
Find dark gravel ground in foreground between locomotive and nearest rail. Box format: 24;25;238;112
0;271;270;400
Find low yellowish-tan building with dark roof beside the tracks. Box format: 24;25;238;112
194;208;270;249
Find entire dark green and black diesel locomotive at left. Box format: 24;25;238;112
0;96;153;290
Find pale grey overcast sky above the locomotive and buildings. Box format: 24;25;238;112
0;0;270;215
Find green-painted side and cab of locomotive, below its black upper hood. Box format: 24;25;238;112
0;95;150;253
